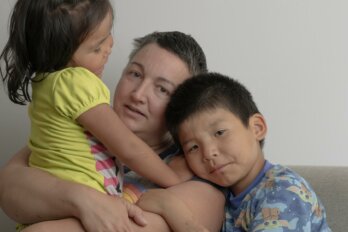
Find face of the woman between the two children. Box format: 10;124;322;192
114;43;190;146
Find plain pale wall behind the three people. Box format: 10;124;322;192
0;0;348;228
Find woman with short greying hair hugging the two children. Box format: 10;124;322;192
0;32;224;232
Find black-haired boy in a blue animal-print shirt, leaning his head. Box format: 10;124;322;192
139;73;331;232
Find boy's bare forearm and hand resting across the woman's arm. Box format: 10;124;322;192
137;189;208;232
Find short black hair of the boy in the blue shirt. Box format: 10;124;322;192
165;72;264;146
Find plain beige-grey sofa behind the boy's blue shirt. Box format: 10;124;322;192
0;166;348;232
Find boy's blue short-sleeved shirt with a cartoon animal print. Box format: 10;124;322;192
226;165;330;231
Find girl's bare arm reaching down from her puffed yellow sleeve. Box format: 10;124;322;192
77;104;180;187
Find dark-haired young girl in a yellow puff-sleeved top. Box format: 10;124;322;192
0;0;179;203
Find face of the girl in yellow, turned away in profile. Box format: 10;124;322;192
68;13;113;77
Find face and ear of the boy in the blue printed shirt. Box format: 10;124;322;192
179;107;267;194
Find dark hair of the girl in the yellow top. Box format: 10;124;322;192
0;0;113;105
